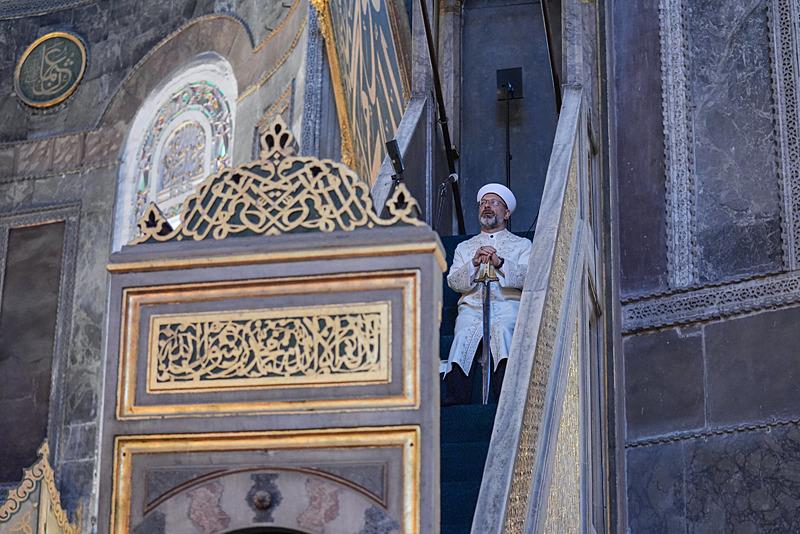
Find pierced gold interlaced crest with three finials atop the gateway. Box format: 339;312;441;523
130;116;424;245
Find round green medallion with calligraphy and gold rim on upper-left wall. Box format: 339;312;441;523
14;32;86;107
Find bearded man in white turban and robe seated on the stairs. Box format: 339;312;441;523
440;183;531;404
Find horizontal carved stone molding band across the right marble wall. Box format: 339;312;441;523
622;271;800;334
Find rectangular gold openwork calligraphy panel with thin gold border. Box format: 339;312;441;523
148;301;391;392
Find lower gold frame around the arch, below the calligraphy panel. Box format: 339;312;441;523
109;425;421;533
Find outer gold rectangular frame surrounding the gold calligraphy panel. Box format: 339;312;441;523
116;269;421;420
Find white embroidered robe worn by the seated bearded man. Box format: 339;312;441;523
439;230;531;374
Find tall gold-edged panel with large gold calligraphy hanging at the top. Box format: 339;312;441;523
312;0;410;182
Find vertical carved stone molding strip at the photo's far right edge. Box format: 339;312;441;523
769;0;800;270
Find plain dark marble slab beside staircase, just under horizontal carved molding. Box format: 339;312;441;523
623;328;705;440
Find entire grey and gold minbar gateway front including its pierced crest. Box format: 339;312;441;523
97;118;445;534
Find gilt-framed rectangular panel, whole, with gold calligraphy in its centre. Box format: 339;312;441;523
116;269;421;420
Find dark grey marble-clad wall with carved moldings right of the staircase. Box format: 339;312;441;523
608;0;800;533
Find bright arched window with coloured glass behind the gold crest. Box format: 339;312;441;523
113;53;238;251
